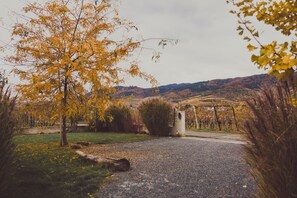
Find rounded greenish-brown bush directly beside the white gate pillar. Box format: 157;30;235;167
138;98;173;136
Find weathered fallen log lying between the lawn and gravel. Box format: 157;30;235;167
76;151;130;172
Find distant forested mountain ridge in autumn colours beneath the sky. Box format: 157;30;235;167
115;74;276;102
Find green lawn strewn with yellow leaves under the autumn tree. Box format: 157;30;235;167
6;133;153;198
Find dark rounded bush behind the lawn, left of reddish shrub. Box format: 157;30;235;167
105;104;133;133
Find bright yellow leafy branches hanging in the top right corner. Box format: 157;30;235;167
227;0;297;79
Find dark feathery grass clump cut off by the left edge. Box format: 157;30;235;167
0;74;15;193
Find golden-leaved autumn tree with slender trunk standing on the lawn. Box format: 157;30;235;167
8;0;169;145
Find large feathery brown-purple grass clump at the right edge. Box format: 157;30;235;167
245;86;297;197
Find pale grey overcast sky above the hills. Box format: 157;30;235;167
0;0;264;87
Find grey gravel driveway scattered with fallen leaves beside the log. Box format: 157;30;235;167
85;138;255;198
